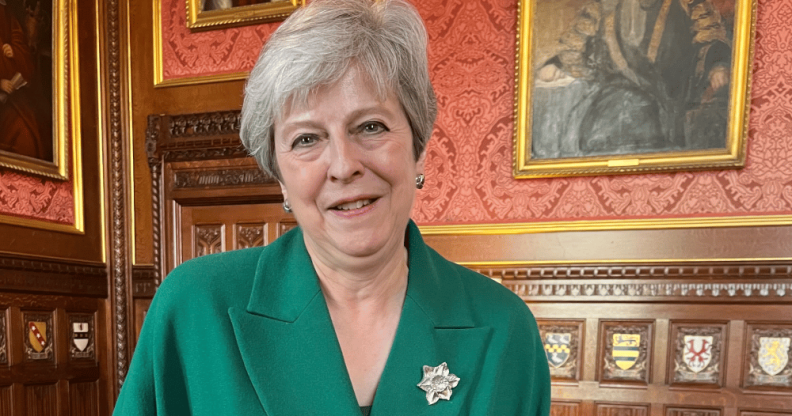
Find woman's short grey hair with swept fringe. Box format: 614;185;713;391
239;0;437;180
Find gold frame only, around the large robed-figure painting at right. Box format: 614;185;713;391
513;0;756;179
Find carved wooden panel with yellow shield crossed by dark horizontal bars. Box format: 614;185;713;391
599;321;654;384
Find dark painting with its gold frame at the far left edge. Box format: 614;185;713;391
0;0;80;180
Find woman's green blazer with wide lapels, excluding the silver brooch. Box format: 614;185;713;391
115;222;550;416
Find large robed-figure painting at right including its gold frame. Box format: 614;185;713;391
514;0;756;178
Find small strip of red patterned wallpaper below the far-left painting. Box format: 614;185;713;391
0;169;74;224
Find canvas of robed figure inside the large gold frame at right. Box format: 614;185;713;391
531;0;734;159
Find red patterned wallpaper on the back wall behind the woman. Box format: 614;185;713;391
161;0;792;224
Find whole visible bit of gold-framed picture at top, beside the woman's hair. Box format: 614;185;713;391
186;0;304;31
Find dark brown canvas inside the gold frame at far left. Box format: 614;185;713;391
0;0;54;162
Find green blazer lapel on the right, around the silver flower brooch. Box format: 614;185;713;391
372;226;492;416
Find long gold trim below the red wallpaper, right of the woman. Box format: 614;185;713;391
418;215;792;235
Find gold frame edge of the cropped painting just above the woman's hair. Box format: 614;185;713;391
186;0;303;31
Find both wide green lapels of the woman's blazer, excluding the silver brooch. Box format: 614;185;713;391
228;221;491;416
